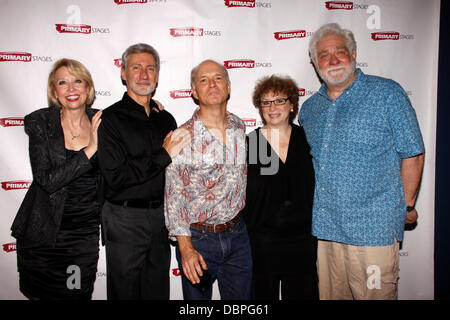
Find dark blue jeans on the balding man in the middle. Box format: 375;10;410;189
176;217;252;300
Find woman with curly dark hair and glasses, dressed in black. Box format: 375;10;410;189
243;75;318;300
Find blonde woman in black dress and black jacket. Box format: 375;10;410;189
11;59;101;300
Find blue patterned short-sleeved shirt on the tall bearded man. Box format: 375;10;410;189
299;69;424;246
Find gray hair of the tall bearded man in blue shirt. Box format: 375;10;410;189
309;23;356;61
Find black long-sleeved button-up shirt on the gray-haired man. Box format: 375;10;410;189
98;92;177;202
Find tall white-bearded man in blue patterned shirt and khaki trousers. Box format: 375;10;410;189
299;23;425;299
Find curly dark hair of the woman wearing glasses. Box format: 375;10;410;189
253;75;299;124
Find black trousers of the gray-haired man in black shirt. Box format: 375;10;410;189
102;201;171;300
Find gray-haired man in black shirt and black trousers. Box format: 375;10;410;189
98;43;190;300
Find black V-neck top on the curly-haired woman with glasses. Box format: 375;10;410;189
243;125;317;275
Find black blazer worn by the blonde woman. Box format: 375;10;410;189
11;107;98;249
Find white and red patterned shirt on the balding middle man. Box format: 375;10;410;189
164;109;247;240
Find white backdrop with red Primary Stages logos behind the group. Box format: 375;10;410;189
0;0;440;299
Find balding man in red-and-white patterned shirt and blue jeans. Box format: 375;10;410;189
164;60;252;300
